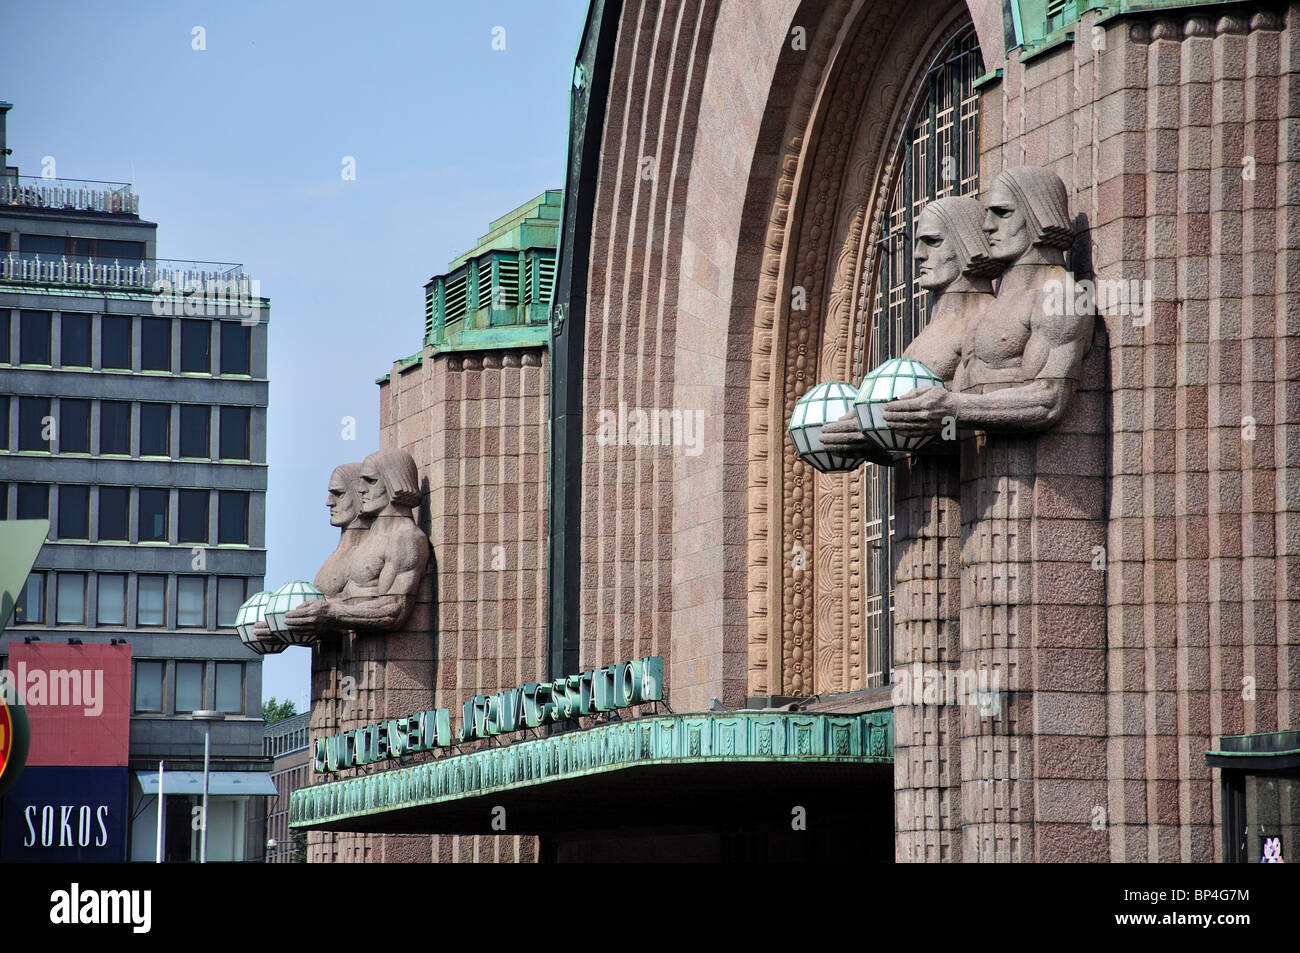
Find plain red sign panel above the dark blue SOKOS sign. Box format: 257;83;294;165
9;642;131;767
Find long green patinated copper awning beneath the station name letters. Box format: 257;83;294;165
290;711;893;833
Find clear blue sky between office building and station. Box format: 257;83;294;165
0;0;586;710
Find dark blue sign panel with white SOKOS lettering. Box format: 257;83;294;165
0;766;129;863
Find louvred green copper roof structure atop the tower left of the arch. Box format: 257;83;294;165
424;190;564;351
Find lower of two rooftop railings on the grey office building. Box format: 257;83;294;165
0;251;250;298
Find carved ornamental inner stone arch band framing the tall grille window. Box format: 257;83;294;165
733;0;987;696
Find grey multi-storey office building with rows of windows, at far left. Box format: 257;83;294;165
0;104;268;859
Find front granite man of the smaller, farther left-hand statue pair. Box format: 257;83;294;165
285;450;429;633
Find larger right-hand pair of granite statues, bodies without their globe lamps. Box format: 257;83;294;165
822;166;1095;464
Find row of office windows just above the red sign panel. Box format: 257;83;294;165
13;569;248;629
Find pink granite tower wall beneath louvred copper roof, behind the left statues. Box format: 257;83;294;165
308;347;549;861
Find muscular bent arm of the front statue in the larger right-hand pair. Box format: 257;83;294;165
884;298;1095;433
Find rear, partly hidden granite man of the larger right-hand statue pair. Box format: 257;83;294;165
822;198;1005;465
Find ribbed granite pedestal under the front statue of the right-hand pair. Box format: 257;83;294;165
961;341;1108;862
